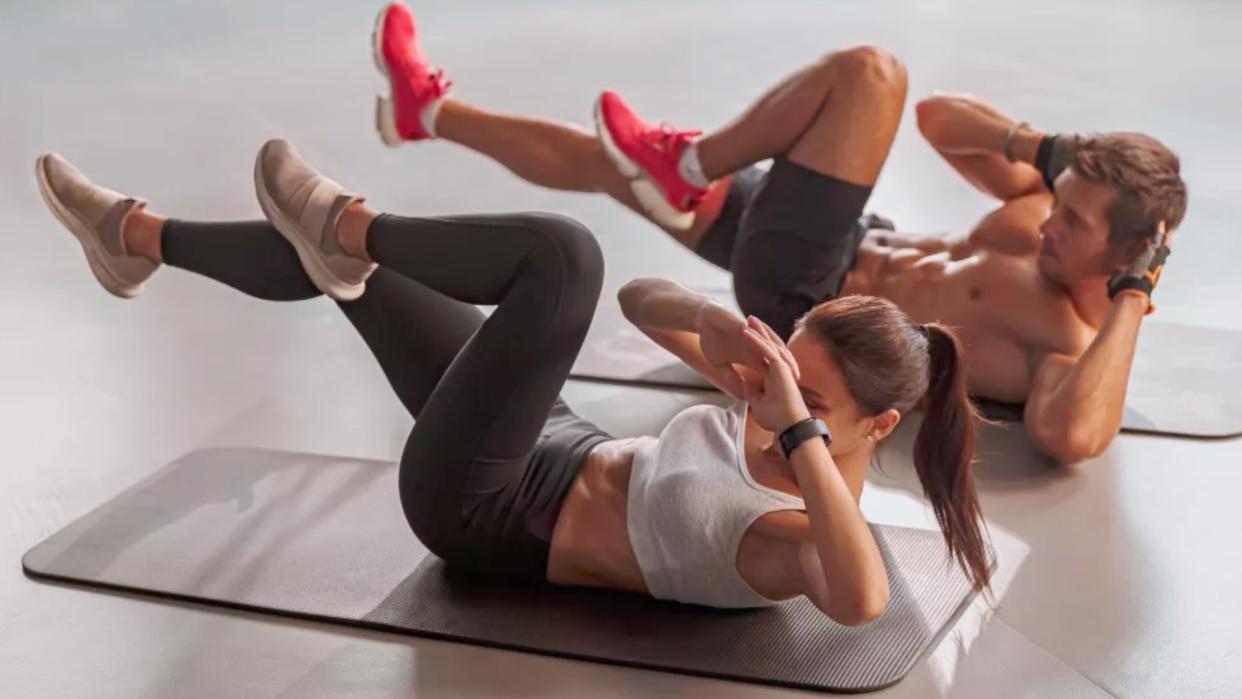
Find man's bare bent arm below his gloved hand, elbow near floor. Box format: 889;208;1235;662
1023;291;1150;464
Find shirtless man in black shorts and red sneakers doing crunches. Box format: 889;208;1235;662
375;4;1186;463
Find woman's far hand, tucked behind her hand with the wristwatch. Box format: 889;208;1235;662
697;303;800;399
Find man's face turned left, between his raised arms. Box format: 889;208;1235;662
1038;169;1117;286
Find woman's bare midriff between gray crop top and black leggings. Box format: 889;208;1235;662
548;438;647;592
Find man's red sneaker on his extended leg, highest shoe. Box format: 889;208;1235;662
371;2;452;147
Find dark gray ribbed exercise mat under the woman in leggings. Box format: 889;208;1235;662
22;448;974;692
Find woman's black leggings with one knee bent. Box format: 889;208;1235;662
163;214;610;581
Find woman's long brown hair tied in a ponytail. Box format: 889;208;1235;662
797;295;991;590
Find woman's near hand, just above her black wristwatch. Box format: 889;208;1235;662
743;319;811;435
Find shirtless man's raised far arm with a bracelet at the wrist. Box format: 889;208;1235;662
915;94;1046;201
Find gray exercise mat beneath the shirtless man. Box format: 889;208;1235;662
573;289;1242;437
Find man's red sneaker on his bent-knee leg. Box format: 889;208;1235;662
595;91;707;230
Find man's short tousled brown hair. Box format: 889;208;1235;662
1071;132;1186;258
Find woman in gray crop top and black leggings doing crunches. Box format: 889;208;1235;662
36;140;989;625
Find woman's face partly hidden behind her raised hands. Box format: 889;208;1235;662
745;330;899;458
